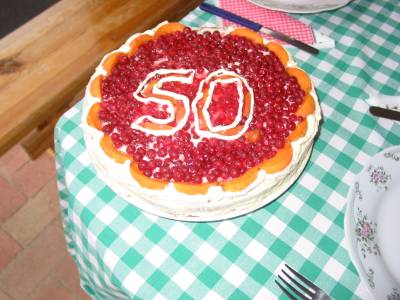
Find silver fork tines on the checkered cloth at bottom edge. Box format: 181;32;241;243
275;264;331;300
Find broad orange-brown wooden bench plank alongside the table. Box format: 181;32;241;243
0;0;201;155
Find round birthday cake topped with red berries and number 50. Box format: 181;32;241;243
82;22;321;221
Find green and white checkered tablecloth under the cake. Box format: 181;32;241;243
56;0;400;299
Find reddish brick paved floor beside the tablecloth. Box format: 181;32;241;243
0;146;90;300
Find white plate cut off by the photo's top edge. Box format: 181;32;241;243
249;0;351;14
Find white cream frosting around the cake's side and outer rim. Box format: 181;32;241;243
82;23;321;221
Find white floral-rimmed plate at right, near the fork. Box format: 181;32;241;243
344;146;400;300
